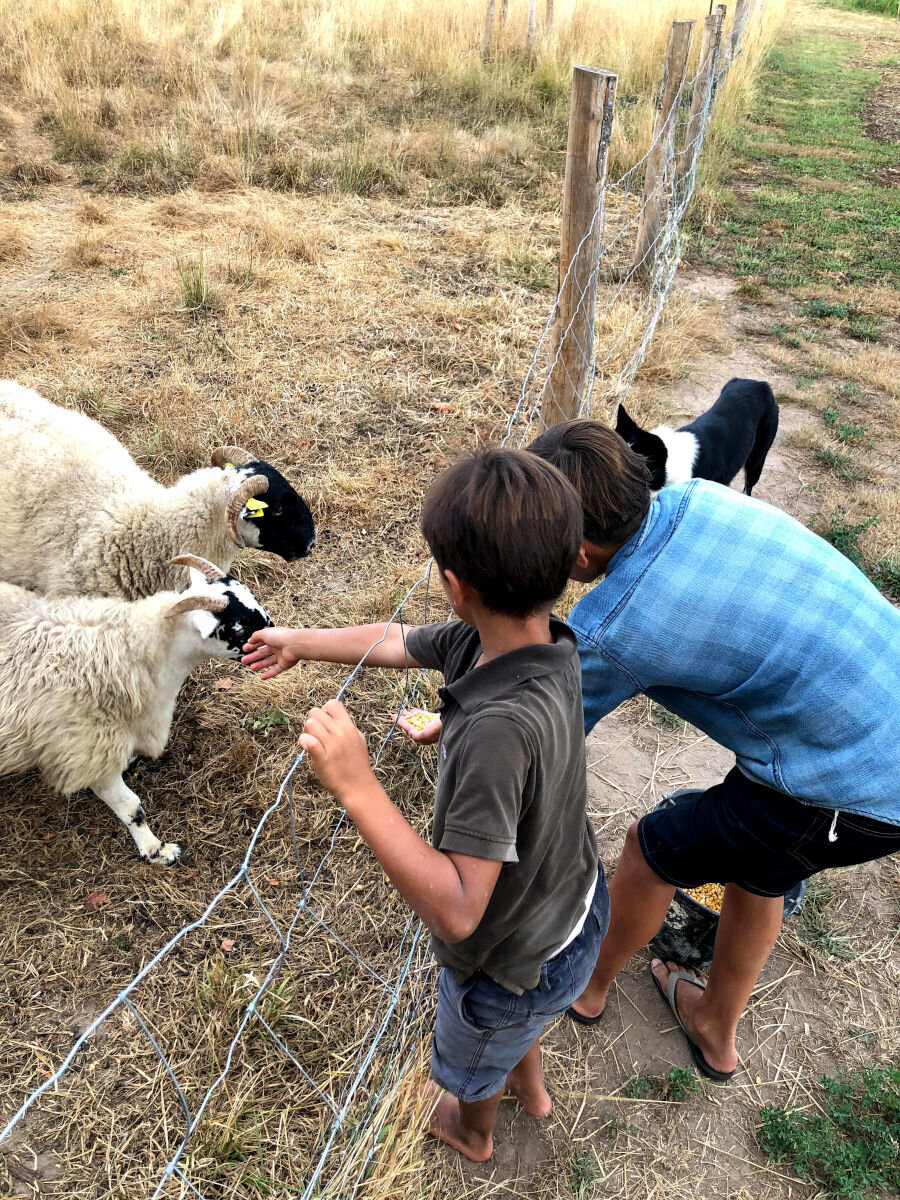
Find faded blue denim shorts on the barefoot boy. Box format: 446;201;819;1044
431;863;610;1103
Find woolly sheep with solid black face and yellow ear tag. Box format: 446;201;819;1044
0;380;316;600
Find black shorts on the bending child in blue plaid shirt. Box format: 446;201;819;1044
637;767;900;896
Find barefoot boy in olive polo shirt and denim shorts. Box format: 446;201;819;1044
244;450;608;1162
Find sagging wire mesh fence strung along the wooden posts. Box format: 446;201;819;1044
0;8;748;1200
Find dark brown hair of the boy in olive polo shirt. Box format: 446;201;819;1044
422;450;582;617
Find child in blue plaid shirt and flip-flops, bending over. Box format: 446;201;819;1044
530;421;900;1080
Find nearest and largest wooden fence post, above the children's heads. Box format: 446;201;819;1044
541;67;618;425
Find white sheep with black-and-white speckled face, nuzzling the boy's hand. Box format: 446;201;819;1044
0;554;271;864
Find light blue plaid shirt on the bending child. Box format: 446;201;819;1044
569;480;900;824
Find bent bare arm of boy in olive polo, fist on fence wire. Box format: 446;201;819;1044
300;700;503;942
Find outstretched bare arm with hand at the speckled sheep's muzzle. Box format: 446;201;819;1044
241;622;420;679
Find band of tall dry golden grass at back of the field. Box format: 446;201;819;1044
0;0;781;205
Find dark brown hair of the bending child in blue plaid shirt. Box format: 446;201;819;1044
528;420;650;546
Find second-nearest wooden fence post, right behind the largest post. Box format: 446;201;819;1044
634;20;694;275
